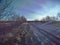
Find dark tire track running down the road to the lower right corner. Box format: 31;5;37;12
30;24;60;45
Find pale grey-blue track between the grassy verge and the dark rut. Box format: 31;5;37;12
30;25;53;45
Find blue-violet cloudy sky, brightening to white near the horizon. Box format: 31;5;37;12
13;0;60;20
